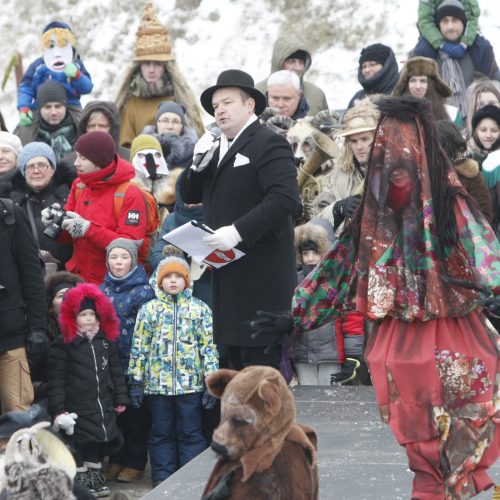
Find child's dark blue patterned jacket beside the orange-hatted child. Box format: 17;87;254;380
101;266;155;375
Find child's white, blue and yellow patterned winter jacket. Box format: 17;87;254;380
129;270;219;396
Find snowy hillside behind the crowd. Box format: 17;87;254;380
0;0;500;129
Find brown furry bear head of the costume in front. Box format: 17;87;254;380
206;366;295;469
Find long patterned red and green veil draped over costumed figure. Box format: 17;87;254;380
293;98;500;330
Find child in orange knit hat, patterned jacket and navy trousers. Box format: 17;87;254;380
129;246;219;486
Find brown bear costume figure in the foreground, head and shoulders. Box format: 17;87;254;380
202;366;318;500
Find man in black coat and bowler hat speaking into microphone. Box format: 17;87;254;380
180;70;300;369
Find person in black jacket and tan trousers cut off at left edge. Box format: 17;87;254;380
0;198;47;413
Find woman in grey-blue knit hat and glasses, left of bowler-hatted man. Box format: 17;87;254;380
142;101;198;170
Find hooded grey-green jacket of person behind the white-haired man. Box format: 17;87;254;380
255;34;328;116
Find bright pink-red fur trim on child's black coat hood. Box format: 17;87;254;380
59;283;120;344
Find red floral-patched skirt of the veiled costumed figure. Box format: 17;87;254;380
365;311;500;500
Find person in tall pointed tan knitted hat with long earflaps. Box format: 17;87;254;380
116;3;204;147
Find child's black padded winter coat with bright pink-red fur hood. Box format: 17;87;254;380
48;283;129;454
